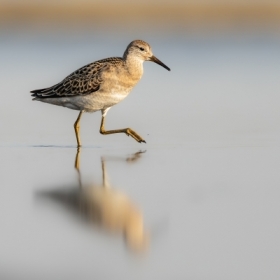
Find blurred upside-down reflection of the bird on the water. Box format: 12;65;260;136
39;148;148;252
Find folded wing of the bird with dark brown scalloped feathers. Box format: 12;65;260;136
31;57;123;98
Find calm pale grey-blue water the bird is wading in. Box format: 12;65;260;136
0;29;280;280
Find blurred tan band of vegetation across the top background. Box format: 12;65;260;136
0;1;280;28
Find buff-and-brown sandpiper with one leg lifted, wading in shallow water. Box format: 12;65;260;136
31;40;170;147
